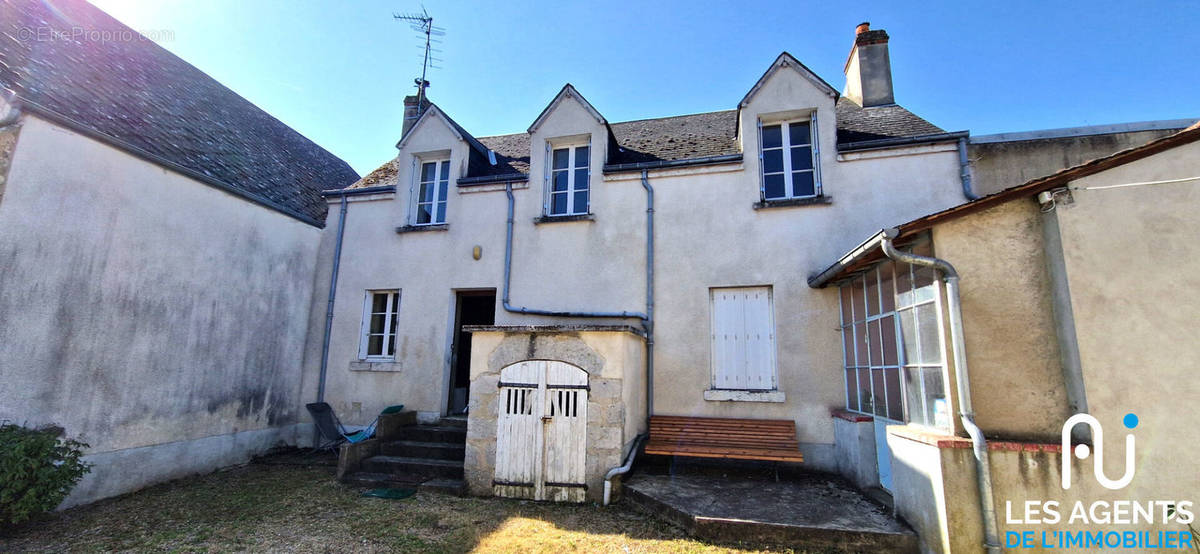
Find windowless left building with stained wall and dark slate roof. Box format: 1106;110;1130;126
0;0;358;505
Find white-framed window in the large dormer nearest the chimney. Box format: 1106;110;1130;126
758;110;823;201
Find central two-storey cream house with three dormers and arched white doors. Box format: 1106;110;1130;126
314;24;967;500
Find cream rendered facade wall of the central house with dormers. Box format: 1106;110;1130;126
306;61;962;469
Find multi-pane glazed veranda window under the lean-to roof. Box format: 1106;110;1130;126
840;242;952;430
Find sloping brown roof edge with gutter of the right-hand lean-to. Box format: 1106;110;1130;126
809;122;1200;287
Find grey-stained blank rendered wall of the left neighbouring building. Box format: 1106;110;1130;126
0;116;320;501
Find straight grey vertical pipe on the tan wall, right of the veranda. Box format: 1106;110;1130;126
1038;188;1092;442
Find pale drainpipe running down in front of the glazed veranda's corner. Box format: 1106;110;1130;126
881;229;1001;553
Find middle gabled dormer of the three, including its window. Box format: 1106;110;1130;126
528;84;613;217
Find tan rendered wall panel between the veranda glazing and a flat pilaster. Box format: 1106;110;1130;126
932;198;1070;440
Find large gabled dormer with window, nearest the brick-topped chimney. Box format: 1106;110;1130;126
738;52;839;203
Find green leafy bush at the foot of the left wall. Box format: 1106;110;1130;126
0;423;91;524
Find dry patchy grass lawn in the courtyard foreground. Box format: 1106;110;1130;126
0;464;811;553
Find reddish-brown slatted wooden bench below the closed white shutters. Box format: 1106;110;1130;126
646;416;804;462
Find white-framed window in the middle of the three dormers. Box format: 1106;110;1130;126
542;138;592;217
